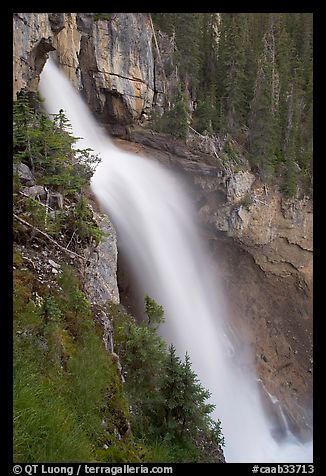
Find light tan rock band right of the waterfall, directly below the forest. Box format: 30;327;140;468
194;171;313;289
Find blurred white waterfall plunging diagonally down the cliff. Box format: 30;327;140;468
40;60;312;463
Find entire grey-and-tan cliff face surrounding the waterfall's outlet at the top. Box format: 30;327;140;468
14;13;154;123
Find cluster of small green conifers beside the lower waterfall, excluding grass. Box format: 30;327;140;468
109;302;224;462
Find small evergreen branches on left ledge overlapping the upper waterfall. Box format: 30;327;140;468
13;92;99;195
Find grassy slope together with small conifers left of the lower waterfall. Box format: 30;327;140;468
14;258;223;462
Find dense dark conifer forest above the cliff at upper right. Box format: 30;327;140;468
152;13;313;196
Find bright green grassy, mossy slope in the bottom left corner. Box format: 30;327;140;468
14;262;134;462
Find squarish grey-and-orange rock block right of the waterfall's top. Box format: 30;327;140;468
79;13;154;124
